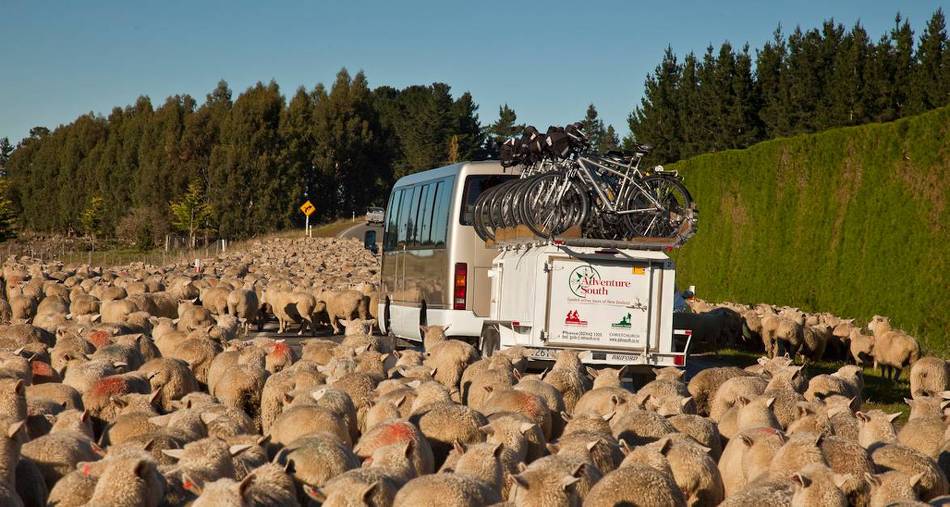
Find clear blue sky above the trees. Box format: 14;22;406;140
0;0;950;142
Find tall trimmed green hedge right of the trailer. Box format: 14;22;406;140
670;107;950;357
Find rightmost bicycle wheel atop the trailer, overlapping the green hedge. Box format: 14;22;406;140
624;174;694;238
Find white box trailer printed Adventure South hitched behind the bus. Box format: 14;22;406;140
479;239;691;367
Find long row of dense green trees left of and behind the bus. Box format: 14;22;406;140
0;69;536;246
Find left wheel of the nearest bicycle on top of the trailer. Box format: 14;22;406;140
522;173;590;238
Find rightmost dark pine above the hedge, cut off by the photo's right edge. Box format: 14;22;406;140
911;8;950;113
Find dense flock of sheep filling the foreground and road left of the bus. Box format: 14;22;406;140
0;240;950;507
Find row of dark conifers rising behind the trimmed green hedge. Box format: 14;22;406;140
626;8;950;162
